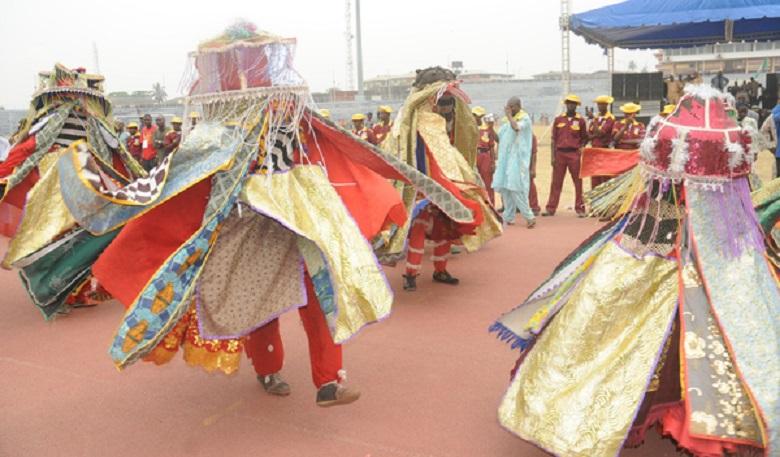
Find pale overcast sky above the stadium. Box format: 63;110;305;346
0;0;655;108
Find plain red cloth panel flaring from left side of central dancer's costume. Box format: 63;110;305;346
92;178;211;307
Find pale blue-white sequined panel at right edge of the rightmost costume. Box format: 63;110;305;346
687;188;780;455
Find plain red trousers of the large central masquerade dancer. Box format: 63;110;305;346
244;273;342;389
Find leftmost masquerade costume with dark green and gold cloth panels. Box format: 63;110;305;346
0;64;146;319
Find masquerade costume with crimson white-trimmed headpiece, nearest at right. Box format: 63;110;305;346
491;86;780;457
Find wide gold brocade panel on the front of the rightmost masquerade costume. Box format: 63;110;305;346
499;243;677;457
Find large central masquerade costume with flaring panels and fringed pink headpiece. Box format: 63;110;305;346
48;24;465;380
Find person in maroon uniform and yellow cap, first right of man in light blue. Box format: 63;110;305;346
542;95;588;217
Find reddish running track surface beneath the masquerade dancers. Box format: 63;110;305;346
0;213;678;457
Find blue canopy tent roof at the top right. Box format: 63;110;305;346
569;0;780;49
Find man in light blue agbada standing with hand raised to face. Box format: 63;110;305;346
493;97;536;228
